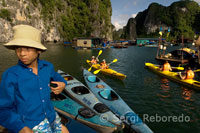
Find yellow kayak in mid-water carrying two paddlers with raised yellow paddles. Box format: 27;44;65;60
86;60;126;80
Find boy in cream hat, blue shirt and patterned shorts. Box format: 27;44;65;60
0;25;69;133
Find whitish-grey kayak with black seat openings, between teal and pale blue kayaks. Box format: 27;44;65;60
58;70;124;130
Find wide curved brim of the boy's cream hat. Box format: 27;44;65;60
4;39;47;51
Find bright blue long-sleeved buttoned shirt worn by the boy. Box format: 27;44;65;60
0;59;67;132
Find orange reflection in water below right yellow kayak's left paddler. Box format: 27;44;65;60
158;78;170;98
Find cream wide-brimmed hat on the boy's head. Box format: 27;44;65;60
4;25;47;51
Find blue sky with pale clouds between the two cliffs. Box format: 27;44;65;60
111;0;200;29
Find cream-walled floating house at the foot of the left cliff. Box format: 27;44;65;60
75;37;104;48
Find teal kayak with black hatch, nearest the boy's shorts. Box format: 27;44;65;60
51;92;117;133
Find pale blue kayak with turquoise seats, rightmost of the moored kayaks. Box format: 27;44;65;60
83;69;152;133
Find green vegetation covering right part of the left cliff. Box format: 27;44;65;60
31;0;112;40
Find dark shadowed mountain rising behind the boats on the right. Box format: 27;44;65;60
114;0;200;38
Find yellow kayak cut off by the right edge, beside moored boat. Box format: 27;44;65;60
145;63;200;90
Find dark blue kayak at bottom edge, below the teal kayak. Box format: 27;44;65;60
59;113;97;133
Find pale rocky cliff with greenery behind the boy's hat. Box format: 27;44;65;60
0;0;112;42
